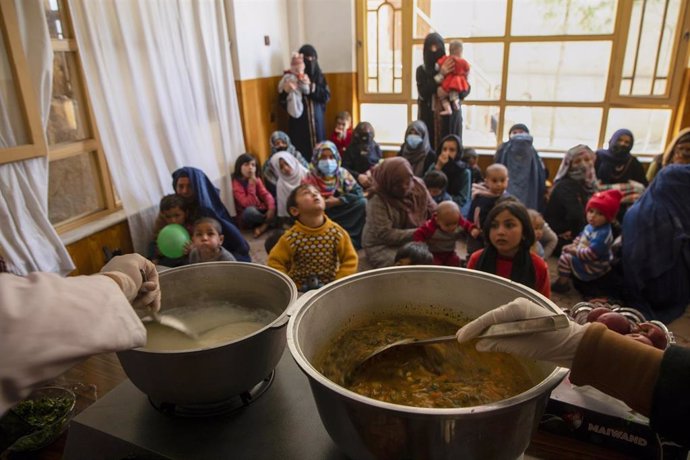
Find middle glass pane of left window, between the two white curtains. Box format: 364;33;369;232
47;52;91;145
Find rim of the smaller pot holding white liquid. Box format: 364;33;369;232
133;261;297;355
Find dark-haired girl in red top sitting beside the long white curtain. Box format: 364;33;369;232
232;153;276;238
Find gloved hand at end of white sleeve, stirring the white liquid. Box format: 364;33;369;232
101;254;161;312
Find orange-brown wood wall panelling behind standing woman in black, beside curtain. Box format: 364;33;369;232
235;73;359;163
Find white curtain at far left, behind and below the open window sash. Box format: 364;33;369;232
0;0;74;275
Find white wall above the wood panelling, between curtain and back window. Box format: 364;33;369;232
227;0;356;80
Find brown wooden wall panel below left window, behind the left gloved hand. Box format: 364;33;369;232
67;221;134;275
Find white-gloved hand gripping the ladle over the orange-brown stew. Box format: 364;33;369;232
456;297;587;368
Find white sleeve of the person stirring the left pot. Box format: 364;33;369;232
0;273;146;415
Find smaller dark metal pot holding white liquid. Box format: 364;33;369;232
118;262;297;405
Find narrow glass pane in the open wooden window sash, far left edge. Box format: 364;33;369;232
0;28;28;148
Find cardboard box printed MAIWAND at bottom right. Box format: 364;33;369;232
539;377;688;460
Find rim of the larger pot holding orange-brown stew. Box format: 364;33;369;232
287;265;569;416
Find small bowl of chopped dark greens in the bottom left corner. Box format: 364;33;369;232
0;387;77;452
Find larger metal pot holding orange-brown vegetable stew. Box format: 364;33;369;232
287;266;567;460
